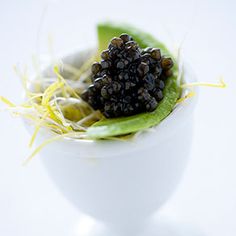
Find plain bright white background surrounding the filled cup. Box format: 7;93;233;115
0;0;236;236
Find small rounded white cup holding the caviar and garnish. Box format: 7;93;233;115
27;48;196;233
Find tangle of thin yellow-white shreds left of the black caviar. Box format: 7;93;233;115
0;56;102;164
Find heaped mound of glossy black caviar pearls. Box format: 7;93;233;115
81;34;173;118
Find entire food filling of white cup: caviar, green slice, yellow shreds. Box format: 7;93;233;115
2;23;201;161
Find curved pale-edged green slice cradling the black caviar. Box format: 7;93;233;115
87;23;180;139
